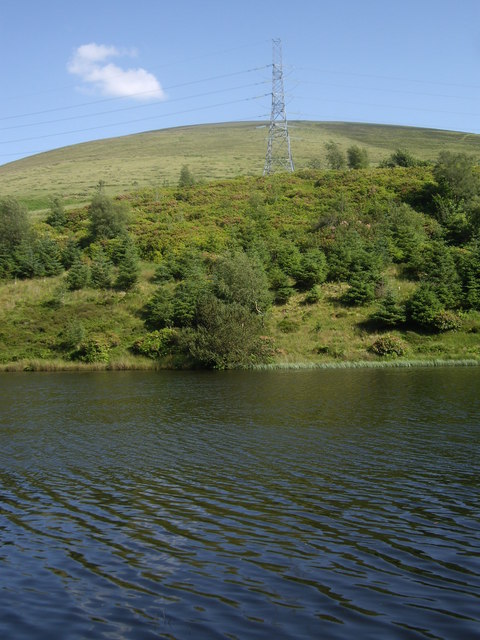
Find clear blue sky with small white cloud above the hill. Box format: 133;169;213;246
0;0;480;164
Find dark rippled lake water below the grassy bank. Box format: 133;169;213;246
0;369;480;640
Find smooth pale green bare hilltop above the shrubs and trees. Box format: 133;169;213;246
0;121;480;210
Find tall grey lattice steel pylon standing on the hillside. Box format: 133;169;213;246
263;39;294;176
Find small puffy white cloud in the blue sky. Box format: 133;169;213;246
67;42;166;100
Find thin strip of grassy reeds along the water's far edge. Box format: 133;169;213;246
0;358;480;373
